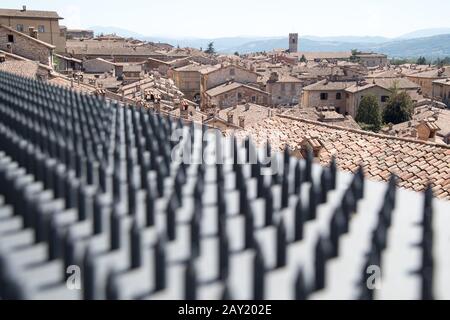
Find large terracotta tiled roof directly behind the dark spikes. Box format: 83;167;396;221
236;116;450;200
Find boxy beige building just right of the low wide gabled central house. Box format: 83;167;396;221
266;72;302;105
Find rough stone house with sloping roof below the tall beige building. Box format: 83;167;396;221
0;25;55;68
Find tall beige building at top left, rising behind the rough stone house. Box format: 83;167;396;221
0;6;66;52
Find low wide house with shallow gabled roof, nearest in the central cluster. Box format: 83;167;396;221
202;81;269;108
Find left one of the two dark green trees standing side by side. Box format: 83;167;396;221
355;94;381;132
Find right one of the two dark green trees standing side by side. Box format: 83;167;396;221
383;84;414;124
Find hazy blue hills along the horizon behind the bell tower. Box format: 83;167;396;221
91;26;450;59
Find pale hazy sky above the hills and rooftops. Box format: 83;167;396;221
0;0;450;37
